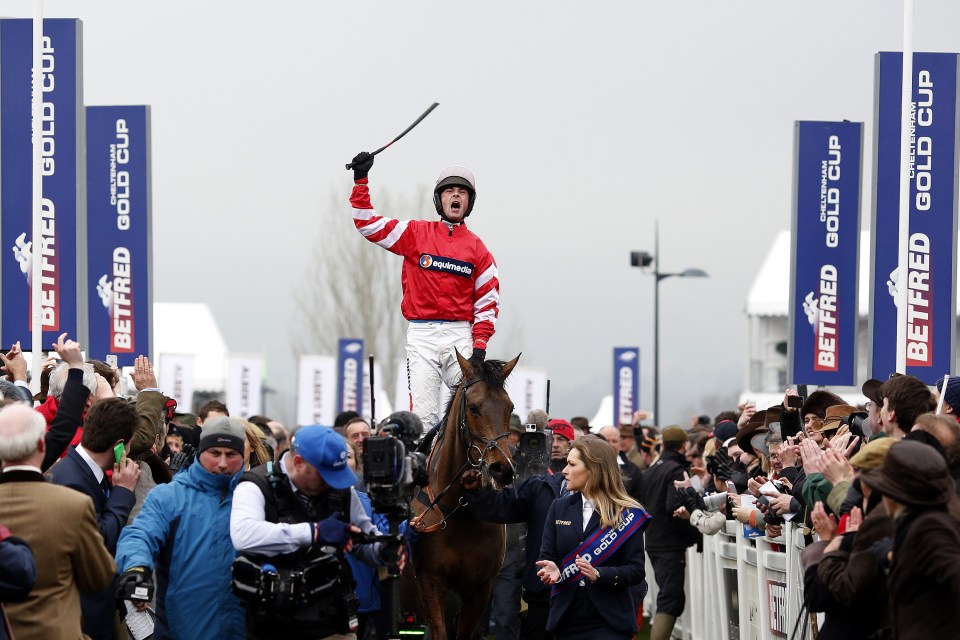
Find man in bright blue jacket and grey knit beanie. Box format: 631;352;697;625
117;418;246;640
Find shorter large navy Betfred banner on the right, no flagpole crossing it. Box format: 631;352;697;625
788;122;863;386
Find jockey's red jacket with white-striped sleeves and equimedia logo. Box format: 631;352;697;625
350;178;500;349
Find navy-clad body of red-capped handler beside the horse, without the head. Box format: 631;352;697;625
462;469;564;640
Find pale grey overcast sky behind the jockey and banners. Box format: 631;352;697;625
2;0;960;424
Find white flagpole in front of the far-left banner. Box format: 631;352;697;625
30;0;43;393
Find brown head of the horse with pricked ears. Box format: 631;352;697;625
457;352;520;486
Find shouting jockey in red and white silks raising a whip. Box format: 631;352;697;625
350;151;500;442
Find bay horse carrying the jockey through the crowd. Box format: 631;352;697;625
410;353;520;640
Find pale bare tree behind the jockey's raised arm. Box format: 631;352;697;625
294;186;433;404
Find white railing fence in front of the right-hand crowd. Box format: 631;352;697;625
644;521;812;640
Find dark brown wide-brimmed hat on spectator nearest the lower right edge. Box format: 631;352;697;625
860;440;956;507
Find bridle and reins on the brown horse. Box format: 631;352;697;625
410;377;516;533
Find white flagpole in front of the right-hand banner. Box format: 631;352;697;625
897;0;913;373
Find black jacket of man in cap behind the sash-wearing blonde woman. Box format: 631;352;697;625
642;449;701;551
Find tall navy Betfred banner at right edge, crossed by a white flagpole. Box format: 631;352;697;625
870;52;958;384
